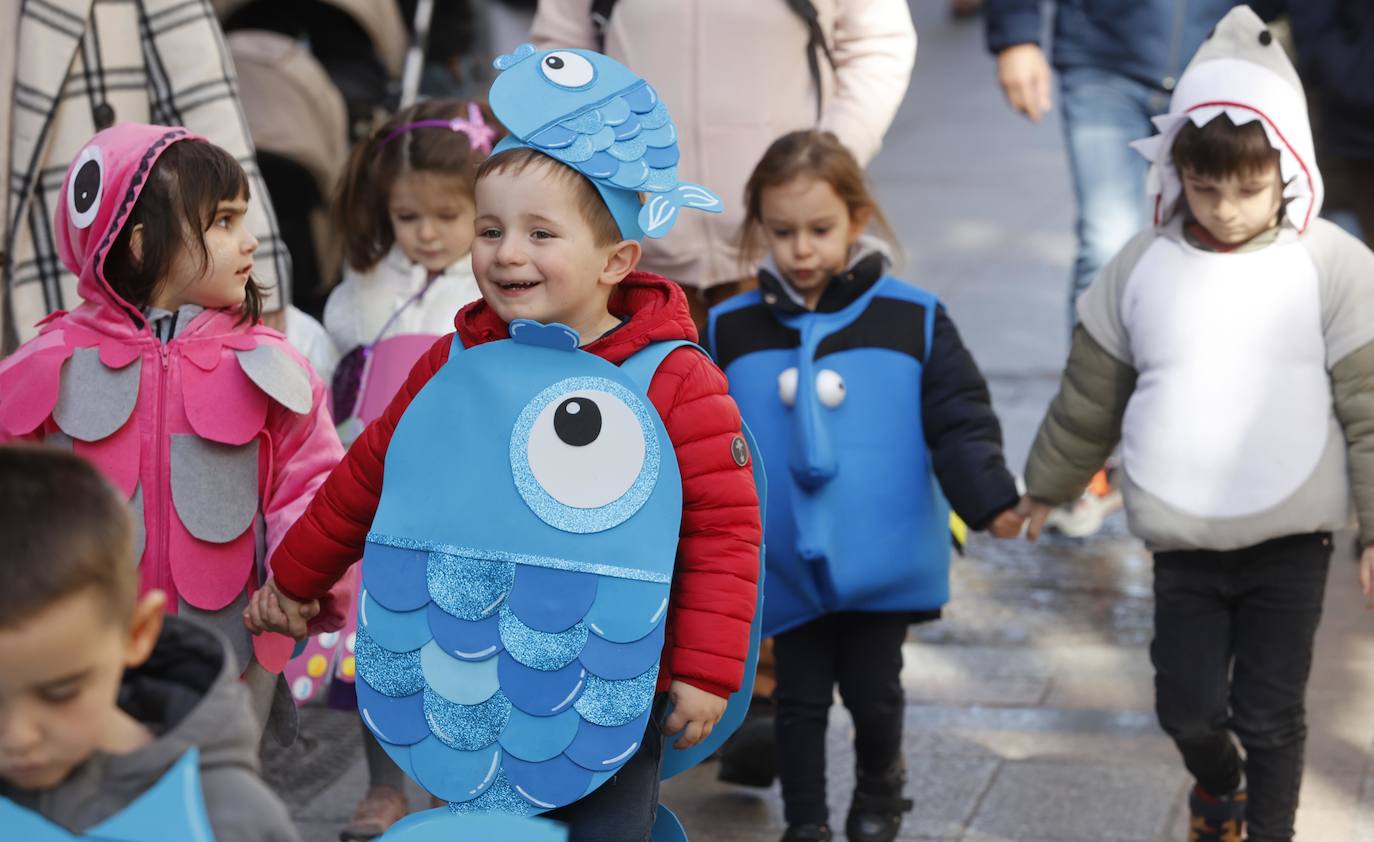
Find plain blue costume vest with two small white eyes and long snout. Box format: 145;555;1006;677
709;277;949;635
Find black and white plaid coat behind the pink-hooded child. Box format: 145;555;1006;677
0;0;290;353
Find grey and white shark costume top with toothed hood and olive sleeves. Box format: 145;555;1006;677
1026;5;1374;549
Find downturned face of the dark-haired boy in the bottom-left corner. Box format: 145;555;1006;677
0;587;165;790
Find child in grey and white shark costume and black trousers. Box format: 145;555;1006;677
1022;5;1374;842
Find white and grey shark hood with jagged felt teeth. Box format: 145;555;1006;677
1131;5;1325;234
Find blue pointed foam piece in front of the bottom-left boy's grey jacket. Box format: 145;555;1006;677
0;749;214;842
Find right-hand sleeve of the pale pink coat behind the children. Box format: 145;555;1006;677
818;0;916;165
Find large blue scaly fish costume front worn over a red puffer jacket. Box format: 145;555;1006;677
356;320;757;816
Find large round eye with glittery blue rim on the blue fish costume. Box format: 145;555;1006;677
511;378;660;533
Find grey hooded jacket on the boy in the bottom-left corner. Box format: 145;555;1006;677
0;617;301;842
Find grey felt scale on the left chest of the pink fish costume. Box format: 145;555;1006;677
52;348;143;441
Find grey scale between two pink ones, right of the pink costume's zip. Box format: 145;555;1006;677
172;434;258;544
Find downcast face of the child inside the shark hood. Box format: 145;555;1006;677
1179;163;1283;246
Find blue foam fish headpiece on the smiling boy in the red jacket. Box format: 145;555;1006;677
489;44;724;240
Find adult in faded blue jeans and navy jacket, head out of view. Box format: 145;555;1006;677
987;0;1283;326
